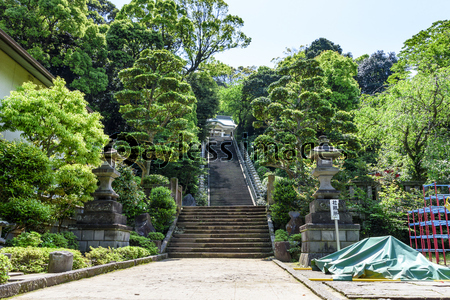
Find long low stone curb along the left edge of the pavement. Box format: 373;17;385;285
0;253;168;299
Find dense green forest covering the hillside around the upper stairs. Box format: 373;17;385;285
0;0;450;239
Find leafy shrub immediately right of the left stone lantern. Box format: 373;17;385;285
112;164;148;226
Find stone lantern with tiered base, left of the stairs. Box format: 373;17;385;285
73;145;131;252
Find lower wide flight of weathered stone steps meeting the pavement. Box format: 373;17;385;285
167;206;272;258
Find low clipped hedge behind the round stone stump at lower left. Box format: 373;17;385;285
0;247;88;274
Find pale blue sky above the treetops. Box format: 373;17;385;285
110;0;450;67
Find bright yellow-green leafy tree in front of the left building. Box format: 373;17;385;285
0;78;108;229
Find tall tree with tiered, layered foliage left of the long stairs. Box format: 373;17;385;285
116;50;196;176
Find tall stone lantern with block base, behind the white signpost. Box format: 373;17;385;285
300;136;359;267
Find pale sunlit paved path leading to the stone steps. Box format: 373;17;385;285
13;259;321;300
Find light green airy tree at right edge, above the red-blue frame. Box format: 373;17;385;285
356;68;450;180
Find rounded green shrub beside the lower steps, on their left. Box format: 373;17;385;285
149;187;177;232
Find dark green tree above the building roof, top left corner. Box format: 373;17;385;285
0;0;108;98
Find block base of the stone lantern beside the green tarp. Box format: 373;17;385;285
299;223;360;267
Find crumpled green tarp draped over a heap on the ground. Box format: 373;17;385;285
311;236;450;280
